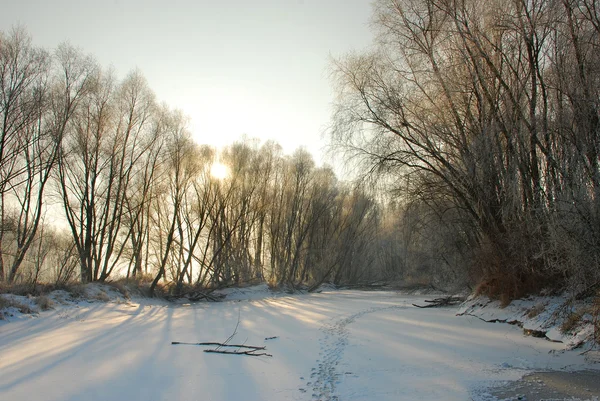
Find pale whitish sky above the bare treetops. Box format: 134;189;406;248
0;0;372;161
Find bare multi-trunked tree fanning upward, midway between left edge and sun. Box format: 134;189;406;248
58;58;156;281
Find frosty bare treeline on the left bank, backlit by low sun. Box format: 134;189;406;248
0;29;391;293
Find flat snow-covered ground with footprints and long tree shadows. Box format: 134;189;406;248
0;289;600;401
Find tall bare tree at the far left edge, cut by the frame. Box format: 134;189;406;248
0;28;49;281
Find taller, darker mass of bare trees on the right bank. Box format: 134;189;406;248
332;0;600;299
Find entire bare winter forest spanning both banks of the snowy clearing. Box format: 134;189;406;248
0;0;600;301
